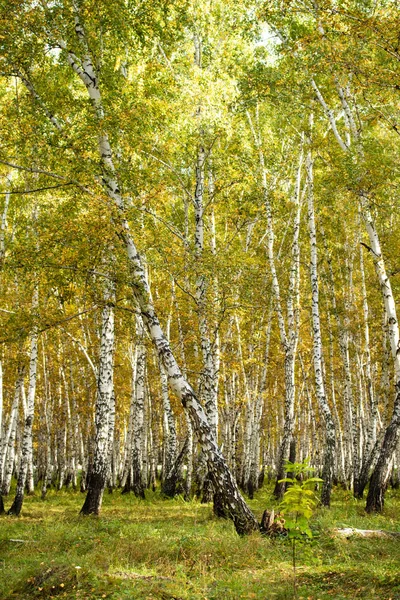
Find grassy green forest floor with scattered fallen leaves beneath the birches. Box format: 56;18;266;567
0;487;400;600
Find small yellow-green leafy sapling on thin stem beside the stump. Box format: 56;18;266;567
279;459;322;598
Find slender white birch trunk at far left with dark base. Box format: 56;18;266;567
8;285;39;516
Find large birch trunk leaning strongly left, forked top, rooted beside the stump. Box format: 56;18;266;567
52;13;259;534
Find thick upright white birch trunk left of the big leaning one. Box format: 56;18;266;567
81;289;114;515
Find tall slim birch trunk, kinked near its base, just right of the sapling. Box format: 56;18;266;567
306;143;336;506
